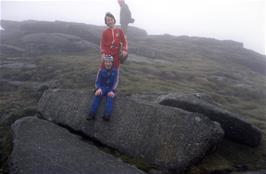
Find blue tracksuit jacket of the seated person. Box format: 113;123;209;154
95;68;119;92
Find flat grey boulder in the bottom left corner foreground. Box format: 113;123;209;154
9;117;144;174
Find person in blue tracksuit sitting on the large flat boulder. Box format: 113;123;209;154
87;56;118;121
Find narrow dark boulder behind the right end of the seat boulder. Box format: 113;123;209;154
158;94;262;146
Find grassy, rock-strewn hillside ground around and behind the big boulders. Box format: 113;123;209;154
0;21;266;174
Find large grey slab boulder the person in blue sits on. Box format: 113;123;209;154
38;89;223;172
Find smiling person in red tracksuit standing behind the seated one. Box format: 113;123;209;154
100;13;128;70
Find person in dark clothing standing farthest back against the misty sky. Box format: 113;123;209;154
118;0;135;35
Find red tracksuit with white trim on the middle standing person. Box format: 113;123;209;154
100;28;128;68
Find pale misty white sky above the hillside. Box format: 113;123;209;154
1;0;266;54
